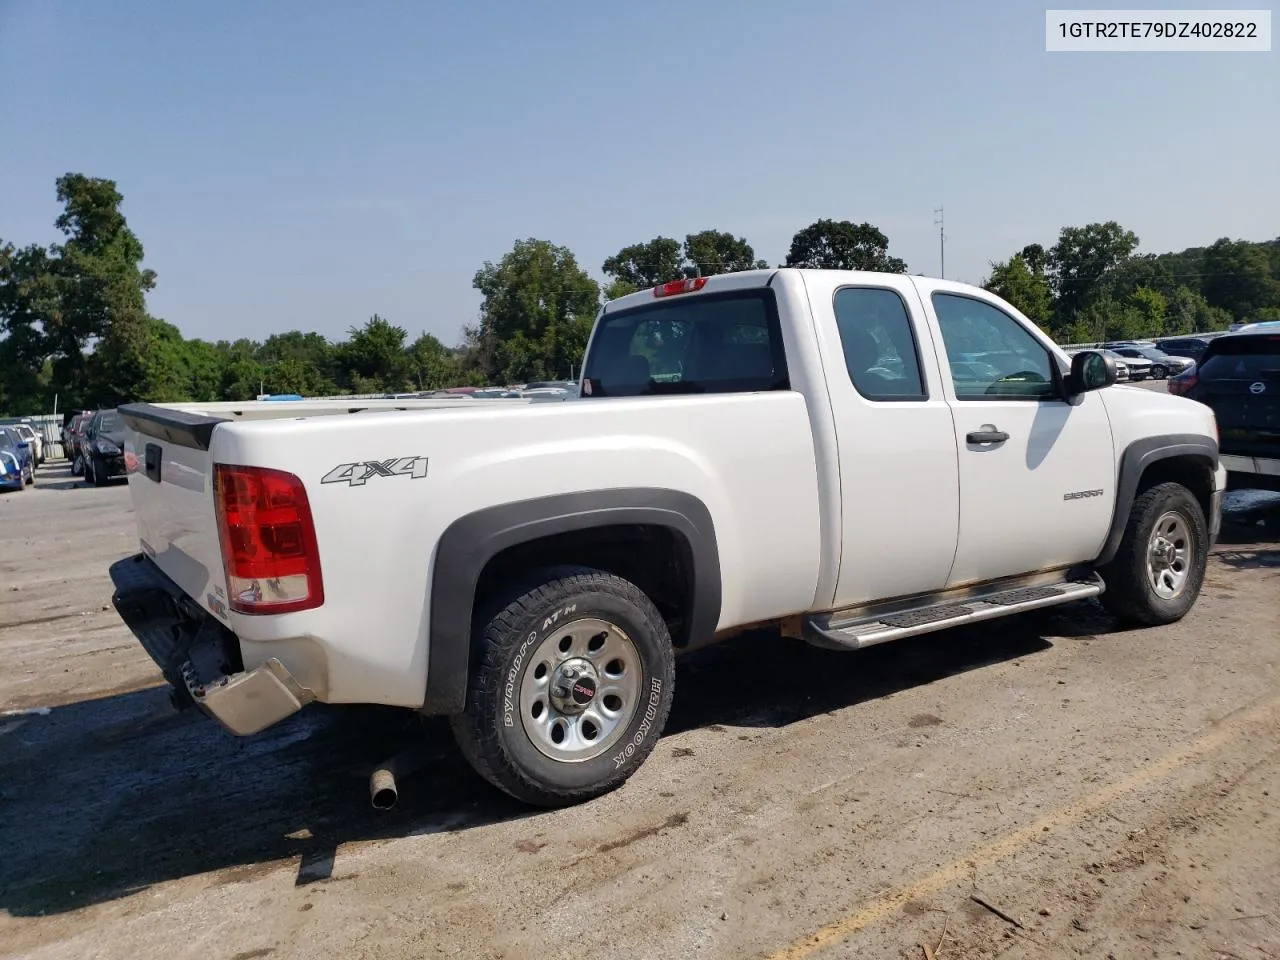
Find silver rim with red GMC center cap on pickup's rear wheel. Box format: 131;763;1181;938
520;618;644;763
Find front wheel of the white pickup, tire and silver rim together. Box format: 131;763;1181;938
1100;483;1208;626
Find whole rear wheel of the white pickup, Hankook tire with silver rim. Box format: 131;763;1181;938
452;567;675;806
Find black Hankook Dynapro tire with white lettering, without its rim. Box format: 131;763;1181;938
451;567;675;808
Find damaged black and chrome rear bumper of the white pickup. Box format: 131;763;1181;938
110;553;315;736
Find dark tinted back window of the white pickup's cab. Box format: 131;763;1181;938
582;287;790;398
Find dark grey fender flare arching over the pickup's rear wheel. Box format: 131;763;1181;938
421;486;722;714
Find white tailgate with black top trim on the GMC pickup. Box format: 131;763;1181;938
120;404;227;617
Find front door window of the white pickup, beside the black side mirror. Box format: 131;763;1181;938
933;293;1057;401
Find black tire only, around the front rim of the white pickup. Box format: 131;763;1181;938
1098;483;1208;626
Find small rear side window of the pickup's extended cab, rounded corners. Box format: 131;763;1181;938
835;287;929;402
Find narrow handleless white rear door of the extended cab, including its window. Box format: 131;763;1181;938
805;274;959;607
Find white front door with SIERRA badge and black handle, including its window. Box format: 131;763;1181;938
916;285;1115;586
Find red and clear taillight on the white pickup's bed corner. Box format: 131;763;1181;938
214;463;324;613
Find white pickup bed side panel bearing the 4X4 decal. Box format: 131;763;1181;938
212;392;820;707
